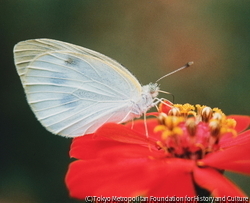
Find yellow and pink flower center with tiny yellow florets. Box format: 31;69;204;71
154;104;237;160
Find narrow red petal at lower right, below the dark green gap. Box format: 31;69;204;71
194;167;246;197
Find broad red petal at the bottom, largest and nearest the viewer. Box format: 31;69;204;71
65;159;195;199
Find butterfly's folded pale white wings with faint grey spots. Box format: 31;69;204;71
14;39;141;137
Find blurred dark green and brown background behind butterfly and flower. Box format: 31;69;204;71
0;0;250;203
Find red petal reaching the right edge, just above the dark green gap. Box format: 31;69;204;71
200;140;250;174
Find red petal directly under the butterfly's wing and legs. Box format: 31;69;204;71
70;127;166;160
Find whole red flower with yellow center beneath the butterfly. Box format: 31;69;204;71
66;104;250;199
